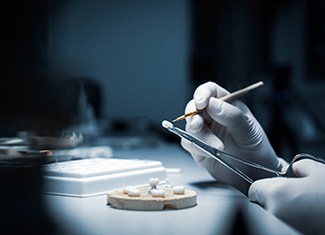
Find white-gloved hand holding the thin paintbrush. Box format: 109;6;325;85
181;82;281;194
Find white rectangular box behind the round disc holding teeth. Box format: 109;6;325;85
44;158;167;197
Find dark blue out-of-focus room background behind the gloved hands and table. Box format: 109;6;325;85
0;0;325;158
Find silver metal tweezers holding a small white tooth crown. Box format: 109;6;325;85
167;124;325;185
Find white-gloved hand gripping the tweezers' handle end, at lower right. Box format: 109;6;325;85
249;159;325;234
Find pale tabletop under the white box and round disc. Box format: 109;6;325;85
43;144;299;235
